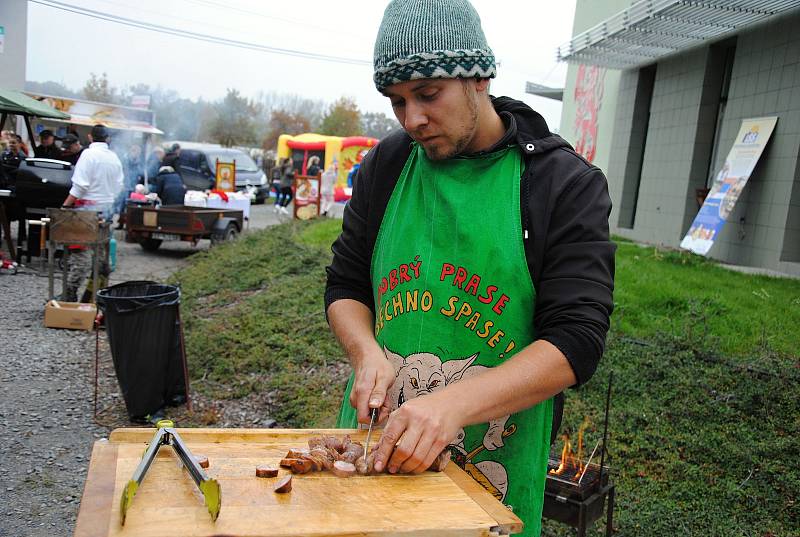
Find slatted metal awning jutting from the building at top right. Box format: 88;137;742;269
557;0;800;69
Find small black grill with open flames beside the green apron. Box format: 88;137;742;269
542;377;615;537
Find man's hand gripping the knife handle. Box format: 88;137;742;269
350;352;396;423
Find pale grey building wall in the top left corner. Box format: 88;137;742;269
0;0;28;90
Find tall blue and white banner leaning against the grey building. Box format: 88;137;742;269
681;116;778;255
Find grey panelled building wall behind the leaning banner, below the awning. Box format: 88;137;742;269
607;13;800;274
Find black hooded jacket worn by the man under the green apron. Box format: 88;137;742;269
325;97;615;385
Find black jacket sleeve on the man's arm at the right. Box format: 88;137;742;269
534;166;616;385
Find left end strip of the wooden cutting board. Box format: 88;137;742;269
73;440;117;537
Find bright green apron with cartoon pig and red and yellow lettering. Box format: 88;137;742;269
338;146;552;535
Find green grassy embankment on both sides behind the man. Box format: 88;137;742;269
170;221;800;537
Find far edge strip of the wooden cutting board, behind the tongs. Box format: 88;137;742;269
108;427;367;444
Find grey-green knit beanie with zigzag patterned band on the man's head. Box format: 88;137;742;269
373;0;497;92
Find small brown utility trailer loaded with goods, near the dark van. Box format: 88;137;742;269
125;203;244;252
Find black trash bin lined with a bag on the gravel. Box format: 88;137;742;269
97;281;186;422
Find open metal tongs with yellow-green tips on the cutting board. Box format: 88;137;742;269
120;420;222;526
